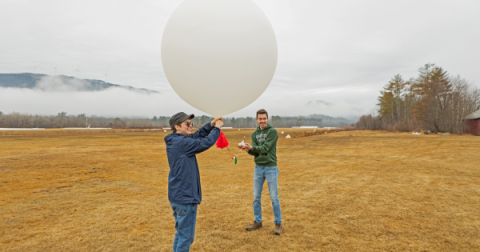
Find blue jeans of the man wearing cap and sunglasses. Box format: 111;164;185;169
170;202;197;252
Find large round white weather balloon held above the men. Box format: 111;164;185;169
162;0;277;116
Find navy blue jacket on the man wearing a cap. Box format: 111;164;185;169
165;123;220;204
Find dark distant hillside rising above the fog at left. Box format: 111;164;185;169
0;73;159;93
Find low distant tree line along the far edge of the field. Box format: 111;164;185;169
0;112;347;128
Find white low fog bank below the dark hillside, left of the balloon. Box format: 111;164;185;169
0;87;199;118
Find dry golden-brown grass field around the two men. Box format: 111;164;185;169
0;129;480;251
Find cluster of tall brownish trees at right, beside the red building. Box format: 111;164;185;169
356;63;480;134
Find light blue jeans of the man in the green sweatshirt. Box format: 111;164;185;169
253;165;282;224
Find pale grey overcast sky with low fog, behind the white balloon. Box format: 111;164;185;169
0;0;480;117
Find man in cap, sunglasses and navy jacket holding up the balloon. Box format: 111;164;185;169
165;112;223;252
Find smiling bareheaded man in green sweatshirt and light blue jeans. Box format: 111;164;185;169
237;109;283;235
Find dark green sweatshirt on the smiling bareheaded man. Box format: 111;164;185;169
248;124;278;166
